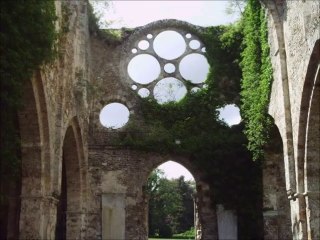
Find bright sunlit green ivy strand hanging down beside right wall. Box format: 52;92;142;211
241;0;272;160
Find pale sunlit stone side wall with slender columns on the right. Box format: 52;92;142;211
262;0;320;239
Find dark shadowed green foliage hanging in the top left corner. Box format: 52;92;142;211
0;0;58;178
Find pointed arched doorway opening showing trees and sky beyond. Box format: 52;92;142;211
145;161;196;238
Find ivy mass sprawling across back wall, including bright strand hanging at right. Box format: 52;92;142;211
113;0;272;237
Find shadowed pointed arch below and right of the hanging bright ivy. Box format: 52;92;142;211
262;118;292;240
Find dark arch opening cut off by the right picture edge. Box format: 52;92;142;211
297;40;320;239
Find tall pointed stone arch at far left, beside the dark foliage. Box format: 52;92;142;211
18;71;51;238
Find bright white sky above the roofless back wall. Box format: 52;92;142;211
91;0;238;28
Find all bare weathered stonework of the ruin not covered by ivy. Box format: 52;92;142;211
1;0;320;240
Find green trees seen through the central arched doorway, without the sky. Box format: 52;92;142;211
146;172;194;237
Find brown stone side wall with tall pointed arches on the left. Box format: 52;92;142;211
17;1;90;239
